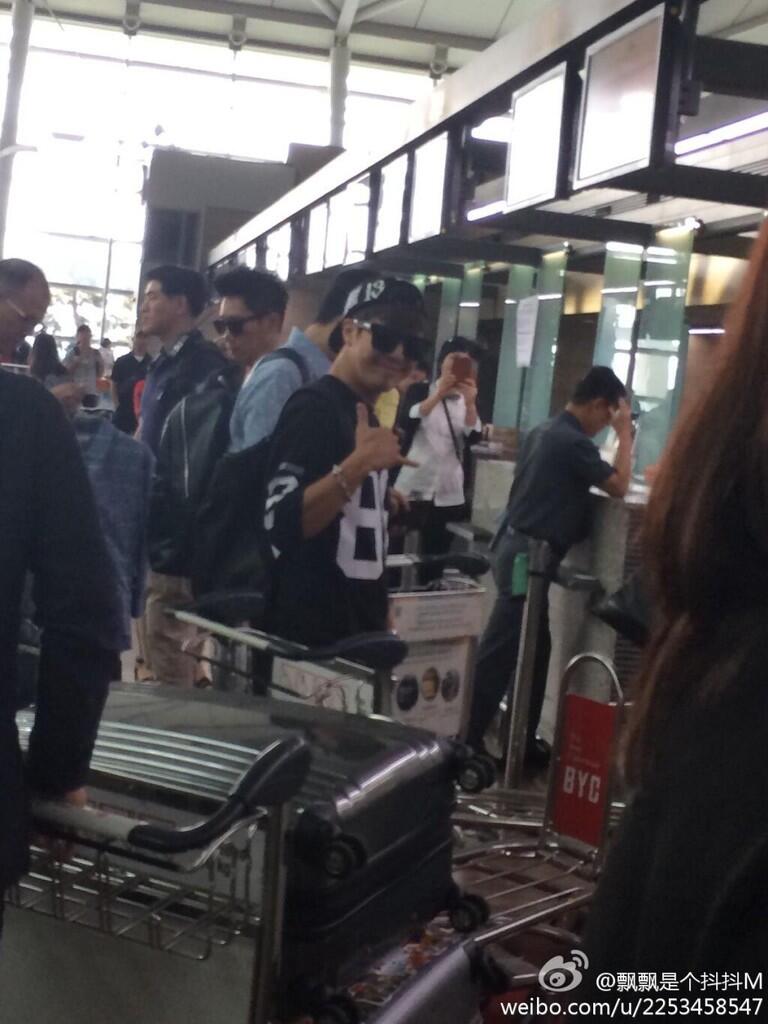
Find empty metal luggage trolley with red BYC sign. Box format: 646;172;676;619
455;653;625;946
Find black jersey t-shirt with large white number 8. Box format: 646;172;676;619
265;376;388;646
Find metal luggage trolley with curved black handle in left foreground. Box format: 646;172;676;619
9;712;309;1024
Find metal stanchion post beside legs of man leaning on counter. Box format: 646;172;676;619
504;541;552;790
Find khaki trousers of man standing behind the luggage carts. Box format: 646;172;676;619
138;571;205;686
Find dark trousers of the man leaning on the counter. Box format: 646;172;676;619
467;535;552;748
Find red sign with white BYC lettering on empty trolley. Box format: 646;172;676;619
552;693;616;847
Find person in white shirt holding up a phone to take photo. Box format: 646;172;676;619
396;337;482;583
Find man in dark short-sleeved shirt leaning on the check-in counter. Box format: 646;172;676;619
467;367;632;764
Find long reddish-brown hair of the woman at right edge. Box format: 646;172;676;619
627;224;768;783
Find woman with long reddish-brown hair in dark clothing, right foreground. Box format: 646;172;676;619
586;225;768;978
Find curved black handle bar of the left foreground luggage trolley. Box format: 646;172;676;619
33;736;310;854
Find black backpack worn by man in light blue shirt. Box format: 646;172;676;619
191;347;309;597
